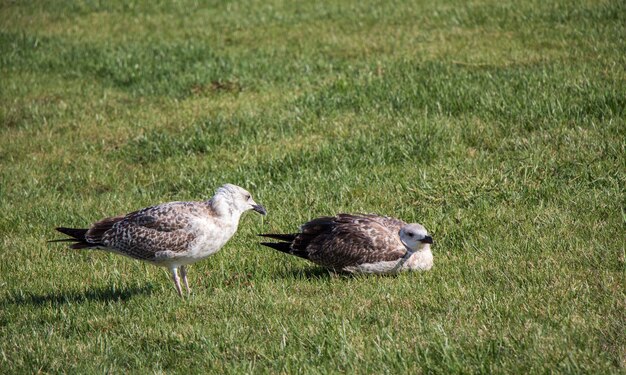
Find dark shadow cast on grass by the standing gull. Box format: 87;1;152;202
0;284;154;306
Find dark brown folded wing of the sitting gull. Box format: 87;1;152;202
292;214;406;270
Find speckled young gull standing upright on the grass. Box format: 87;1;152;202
50;184;267;297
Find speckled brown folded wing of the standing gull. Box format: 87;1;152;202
86;202;208;260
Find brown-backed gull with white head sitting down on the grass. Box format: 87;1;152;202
259;213;433;274
